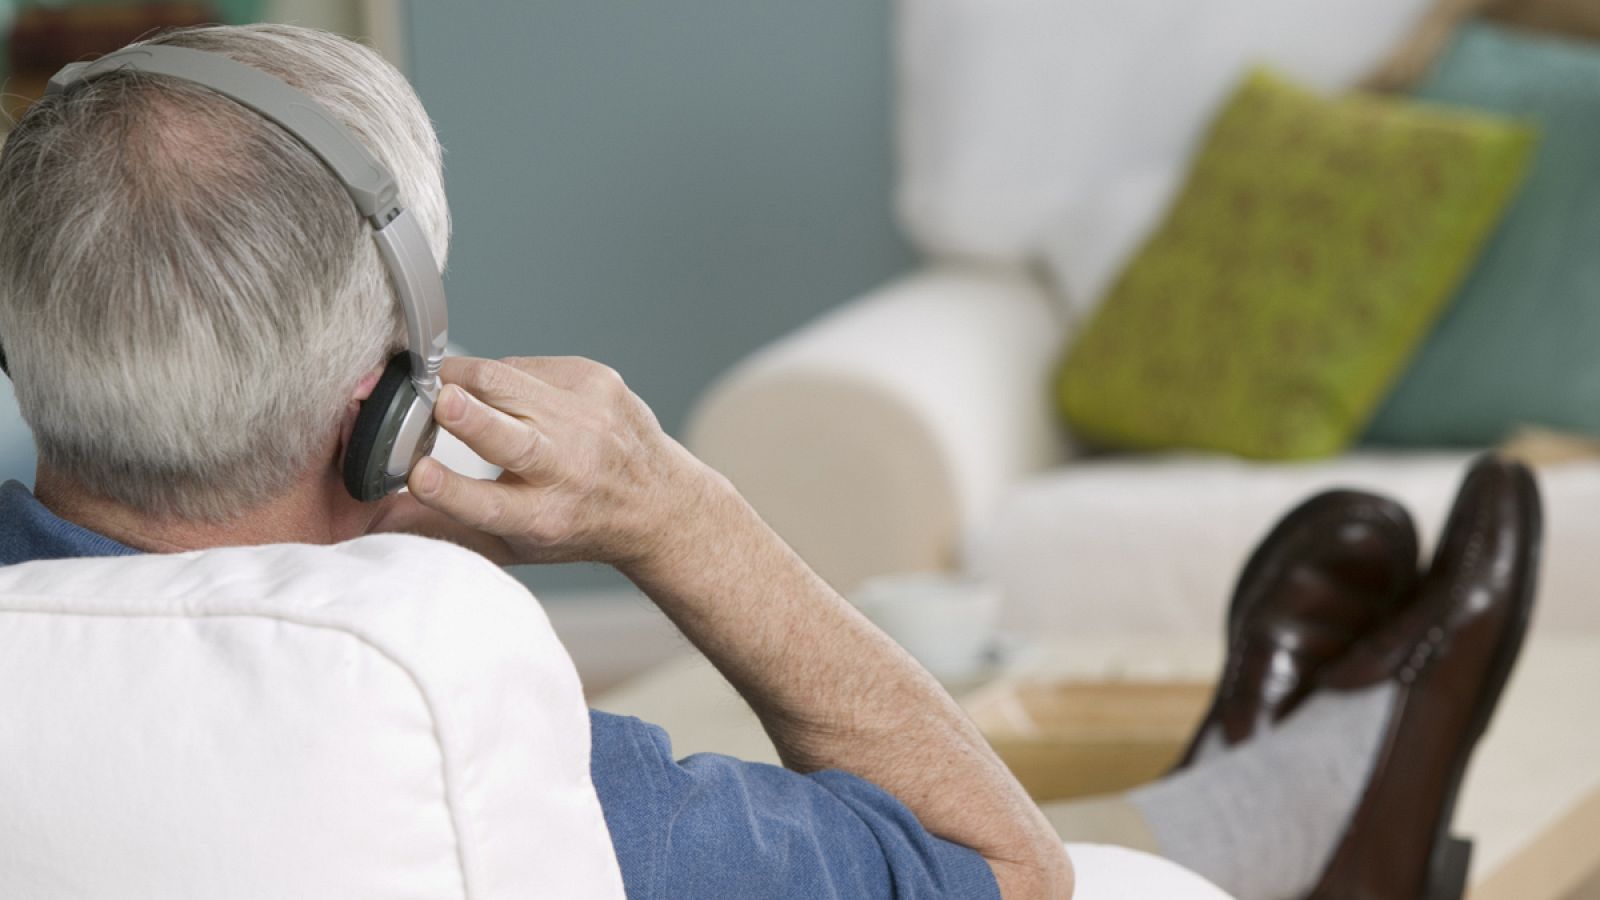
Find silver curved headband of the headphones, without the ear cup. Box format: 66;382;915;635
46;45;448;392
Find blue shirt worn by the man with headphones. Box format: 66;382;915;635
0;482;1000;900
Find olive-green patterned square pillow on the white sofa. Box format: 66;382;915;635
1058;70;1534;460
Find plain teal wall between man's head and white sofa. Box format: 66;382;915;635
408;0;912;589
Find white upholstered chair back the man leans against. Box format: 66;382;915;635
0;536;622;900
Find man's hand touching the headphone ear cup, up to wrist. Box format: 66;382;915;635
400;357;718;569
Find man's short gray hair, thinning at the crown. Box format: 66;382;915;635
0;26;450;520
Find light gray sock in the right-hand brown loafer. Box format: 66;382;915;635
1128;684;1395;900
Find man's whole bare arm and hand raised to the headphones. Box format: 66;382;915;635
400;357;1072;900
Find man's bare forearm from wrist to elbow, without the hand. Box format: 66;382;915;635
622;474;1070;900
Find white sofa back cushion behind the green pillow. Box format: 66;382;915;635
898;0;1430;307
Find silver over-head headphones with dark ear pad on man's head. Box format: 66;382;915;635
10;45;448;501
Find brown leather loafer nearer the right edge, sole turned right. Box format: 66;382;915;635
1310;456;1541;900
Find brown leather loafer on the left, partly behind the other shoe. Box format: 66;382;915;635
1178;490;1418;769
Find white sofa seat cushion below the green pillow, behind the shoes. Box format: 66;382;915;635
968;453;1600;634
